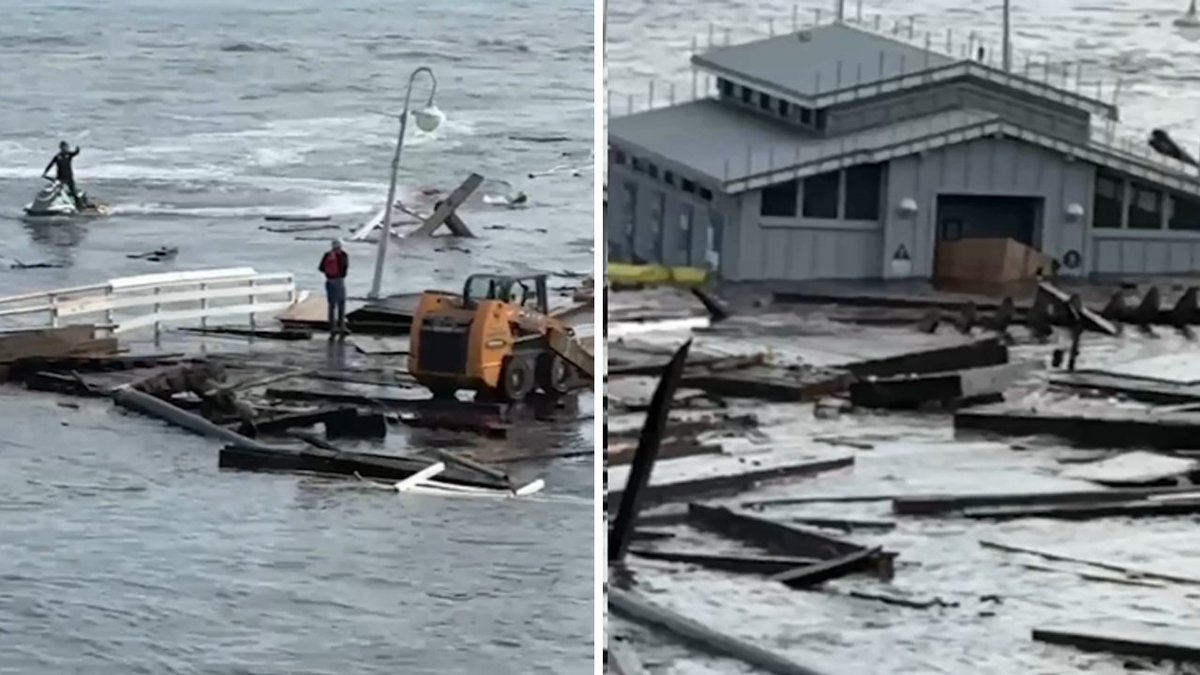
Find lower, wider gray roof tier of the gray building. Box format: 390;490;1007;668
608;100;1200;197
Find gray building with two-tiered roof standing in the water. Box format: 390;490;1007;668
605;24;1200;281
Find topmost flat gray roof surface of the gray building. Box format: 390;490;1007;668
691;24;961;97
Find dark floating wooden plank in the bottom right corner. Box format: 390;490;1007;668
1033;621;1200;663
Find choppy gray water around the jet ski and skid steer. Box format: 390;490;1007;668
0;0;593;674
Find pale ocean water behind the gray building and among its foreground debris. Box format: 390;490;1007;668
606;0;1200;675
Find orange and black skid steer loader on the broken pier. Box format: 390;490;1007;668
408;274;581;402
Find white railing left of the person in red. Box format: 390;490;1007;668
0;267;296;338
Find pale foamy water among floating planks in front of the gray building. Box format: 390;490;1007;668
611;316;1200;675
